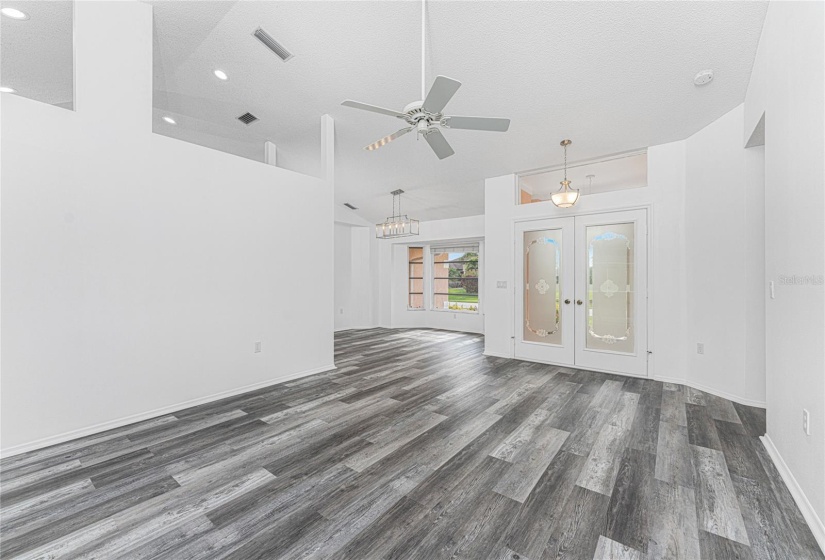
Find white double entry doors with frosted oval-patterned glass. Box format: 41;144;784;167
515;210;647;375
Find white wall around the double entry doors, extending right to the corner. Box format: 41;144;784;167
485;120;765;406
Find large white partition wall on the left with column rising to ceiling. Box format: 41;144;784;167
0;2;333;454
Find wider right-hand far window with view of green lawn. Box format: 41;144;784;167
432;245;478;313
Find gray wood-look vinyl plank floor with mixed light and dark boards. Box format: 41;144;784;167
0;329;825;560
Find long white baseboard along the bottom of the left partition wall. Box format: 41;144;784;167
0;364;336;458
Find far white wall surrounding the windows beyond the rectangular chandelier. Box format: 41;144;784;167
378;216;486;333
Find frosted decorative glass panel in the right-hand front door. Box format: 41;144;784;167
586;223;635;353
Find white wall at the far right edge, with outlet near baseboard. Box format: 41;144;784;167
743;2;825;536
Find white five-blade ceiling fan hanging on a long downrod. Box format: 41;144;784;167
341;0;510;159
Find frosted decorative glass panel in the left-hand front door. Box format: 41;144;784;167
522;229;562;344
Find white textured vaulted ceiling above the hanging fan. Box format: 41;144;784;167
2;0;767;221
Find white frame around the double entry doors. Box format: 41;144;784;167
510;206;655;379
